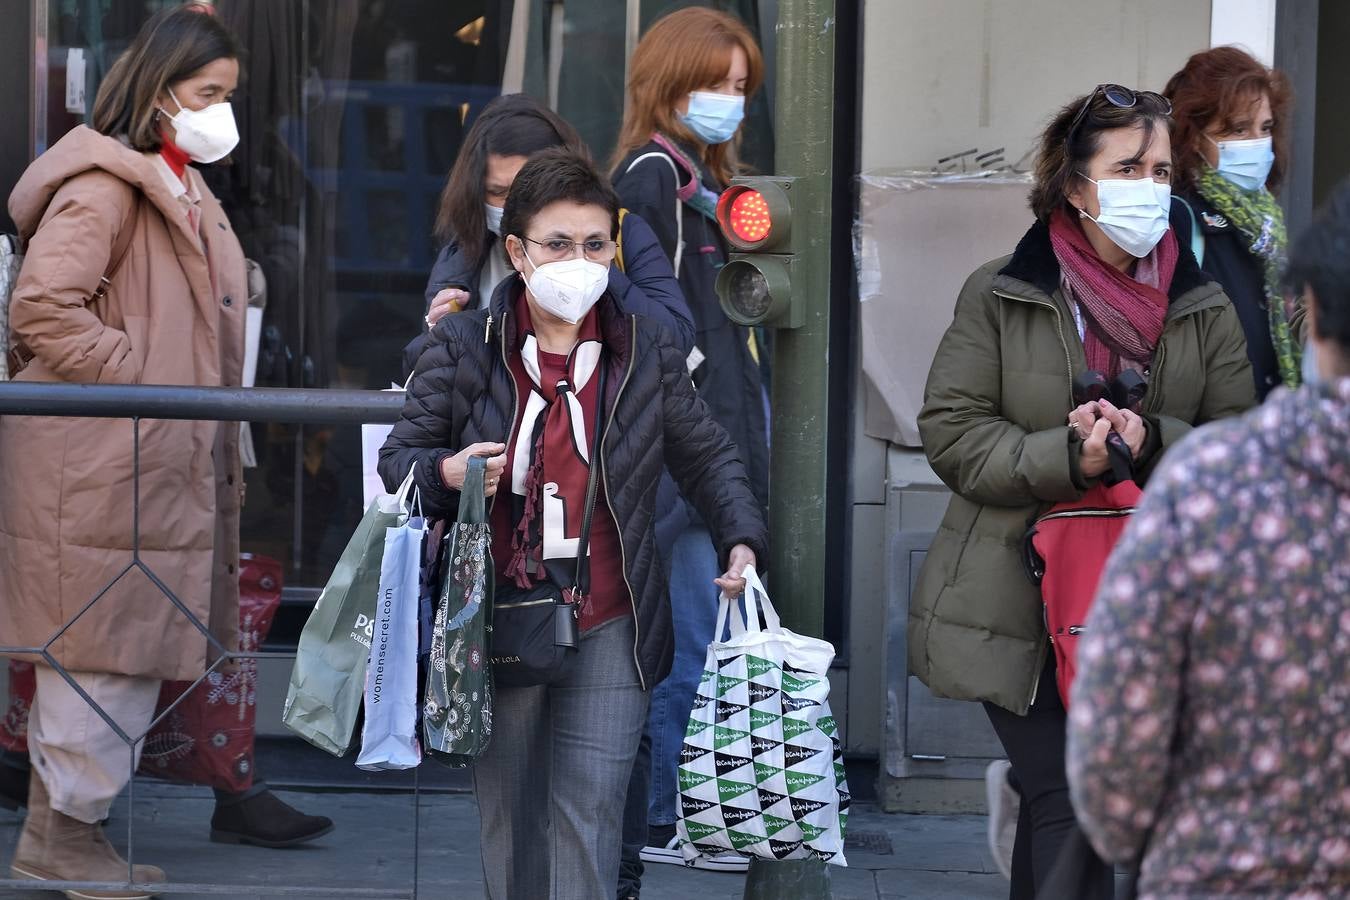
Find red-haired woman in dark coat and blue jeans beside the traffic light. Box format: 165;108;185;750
612;7;768;885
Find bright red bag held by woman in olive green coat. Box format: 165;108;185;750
1023;480;1143;710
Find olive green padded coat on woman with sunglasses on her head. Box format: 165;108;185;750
909;223;1256;715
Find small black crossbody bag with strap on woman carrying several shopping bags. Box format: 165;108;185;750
489;354;606;687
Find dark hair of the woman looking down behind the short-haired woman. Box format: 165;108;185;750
436;93;590;259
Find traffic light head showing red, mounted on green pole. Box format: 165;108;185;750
717;177;803;328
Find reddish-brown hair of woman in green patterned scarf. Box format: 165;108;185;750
1162;47;1293;190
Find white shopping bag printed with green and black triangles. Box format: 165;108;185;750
675;567;849;866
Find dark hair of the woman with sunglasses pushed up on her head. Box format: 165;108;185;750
1030;89;1169;223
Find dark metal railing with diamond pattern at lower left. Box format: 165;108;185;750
0;382;420;900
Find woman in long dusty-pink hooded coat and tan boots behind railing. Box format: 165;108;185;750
0;4;332;900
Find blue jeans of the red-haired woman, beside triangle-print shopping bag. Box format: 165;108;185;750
647;524;721;824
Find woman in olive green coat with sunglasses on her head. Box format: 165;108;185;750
909;85;1256;900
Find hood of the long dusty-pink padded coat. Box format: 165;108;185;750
9;125;187;242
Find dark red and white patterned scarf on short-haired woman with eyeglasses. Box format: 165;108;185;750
505;293;601;588
